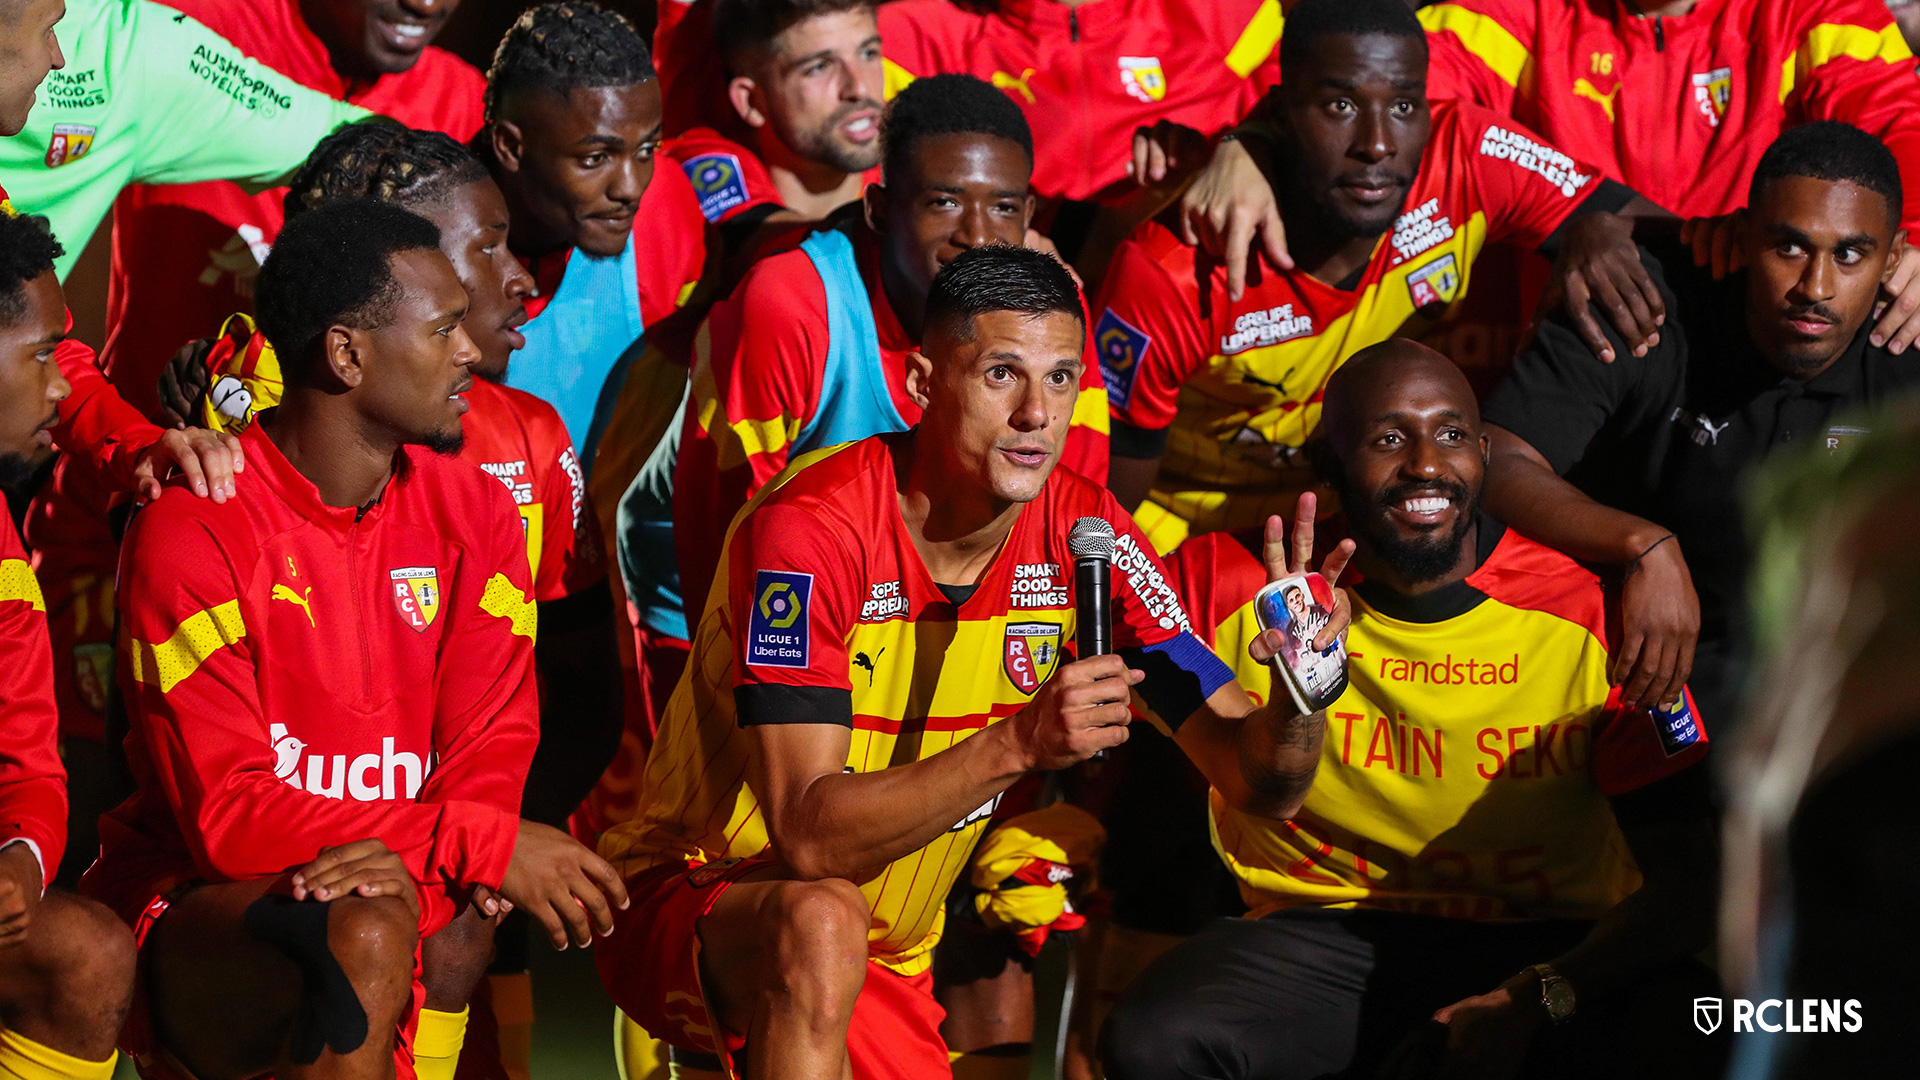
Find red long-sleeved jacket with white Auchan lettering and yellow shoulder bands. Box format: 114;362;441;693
84;417;540;934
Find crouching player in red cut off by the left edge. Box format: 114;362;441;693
0;209;134;1080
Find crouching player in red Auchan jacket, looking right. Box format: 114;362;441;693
83;200;626;1080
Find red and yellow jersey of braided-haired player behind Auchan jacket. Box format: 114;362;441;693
461;379;607;603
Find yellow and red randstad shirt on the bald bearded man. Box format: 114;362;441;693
1167;517;1707;919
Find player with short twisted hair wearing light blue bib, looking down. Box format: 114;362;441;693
476;0;708;857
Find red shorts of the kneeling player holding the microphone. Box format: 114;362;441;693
593;859;952;1080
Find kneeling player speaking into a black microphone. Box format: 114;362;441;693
597;246;1346;1080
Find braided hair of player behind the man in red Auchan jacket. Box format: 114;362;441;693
286;119;488;219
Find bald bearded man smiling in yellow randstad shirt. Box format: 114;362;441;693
1102;340;1722;1080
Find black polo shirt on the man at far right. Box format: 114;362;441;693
1482;246;1920;723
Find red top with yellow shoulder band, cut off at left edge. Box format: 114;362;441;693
0;494;67;882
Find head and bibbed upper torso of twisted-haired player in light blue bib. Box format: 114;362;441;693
478;0;707;469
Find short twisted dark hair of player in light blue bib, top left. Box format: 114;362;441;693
486;0;655;123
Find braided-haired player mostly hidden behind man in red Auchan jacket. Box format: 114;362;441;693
158;121;620;1076
